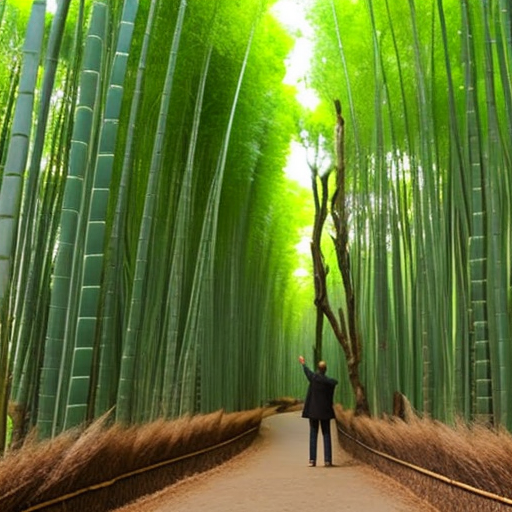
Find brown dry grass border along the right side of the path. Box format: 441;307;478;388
336;406;512;512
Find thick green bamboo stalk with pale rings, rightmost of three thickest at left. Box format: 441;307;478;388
64;0;139;429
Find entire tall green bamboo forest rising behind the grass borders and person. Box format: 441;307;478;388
0;0;512;452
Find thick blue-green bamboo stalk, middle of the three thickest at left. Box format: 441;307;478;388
37;0;107;437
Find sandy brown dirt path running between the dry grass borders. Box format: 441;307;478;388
116;412;434;512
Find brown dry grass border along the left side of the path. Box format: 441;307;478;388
0;409;263;512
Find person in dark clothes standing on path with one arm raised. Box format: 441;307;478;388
299;356;338;467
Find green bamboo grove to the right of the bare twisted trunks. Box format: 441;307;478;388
308;0;511;425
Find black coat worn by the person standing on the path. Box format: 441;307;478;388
302;365;338;420
